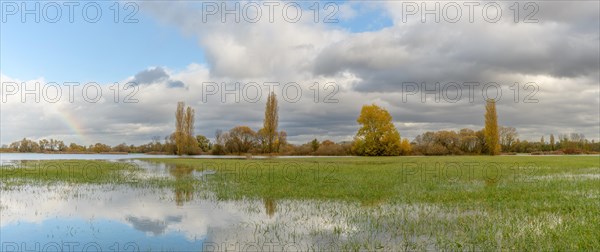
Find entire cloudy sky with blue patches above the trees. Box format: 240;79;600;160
0;1;600;145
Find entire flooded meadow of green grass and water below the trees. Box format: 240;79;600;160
0;156;600;251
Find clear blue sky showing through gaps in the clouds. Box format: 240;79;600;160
0;1;392;83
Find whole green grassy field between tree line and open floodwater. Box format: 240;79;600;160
1;156;600;251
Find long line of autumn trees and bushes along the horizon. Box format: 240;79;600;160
0;98;600;156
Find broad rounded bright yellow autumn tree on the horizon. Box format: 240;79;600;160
352;104;401;156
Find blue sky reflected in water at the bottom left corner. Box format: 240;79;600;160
1;218;203;251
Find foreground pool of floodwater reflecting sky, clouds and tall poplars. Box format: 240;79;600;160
0;161;486;251
